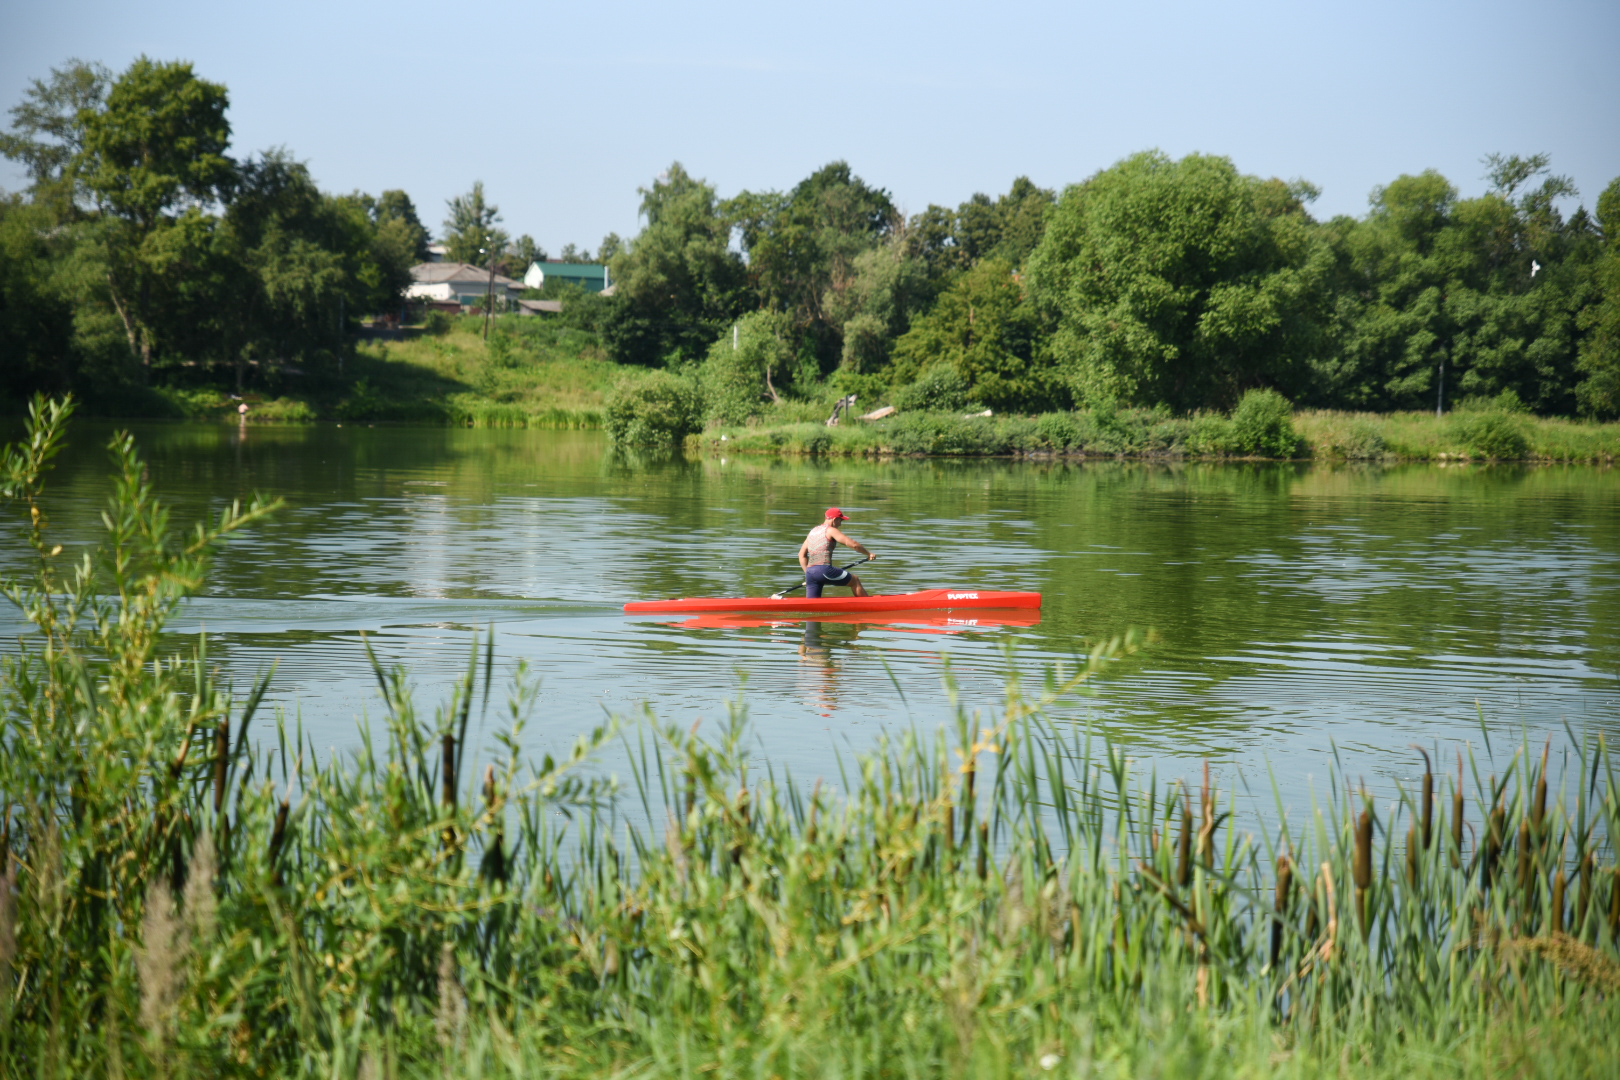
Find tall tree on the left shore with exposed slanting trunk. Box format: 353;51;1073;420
71;57;235;377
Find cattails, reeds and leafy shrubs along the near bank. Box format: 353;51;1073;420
9;401;1620;1080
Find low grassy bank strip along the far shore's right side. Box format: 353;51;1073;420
687;401;1620;465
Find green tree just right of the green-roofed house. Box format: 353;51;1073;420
603;162;747;364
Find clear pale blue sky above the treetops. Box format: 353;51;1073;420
0;0;1620;254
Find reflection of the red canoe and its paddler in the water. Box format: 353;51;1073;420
654;607;1040;717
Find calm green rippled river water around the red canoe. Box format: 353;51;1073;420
3;423;1620;816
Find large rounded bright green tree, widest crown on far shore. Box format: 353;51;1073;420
1029;151;1325;410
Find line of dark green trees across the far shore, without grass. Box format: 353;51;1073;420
9;58;1620;419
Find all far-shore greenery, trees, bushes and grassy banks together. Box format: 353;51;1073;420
0;57;1620;463
